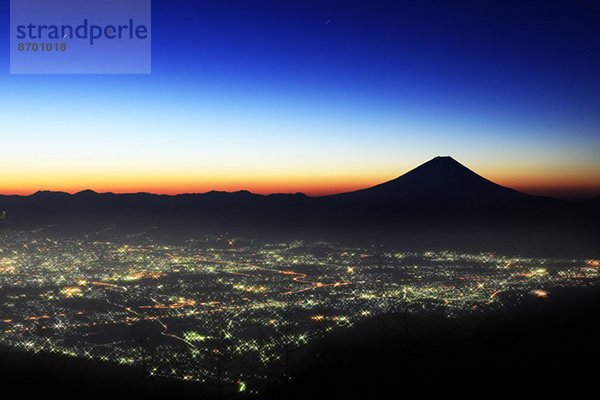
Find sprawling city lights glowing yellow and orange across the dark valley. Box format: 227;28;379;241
0;232;600;392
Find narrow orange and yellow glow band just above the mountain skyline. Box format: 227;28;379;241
0;163;600;198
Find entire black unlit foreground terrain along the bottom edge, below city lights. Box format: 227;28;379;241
0;288;600;400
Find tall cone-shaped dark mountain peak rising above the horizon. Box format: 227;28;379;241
331;156;543;207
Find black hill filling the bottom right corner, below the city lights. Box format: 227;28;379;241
271;288;600;400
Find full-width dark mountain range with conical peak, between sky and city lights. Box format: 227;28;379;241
0;157;600;250
